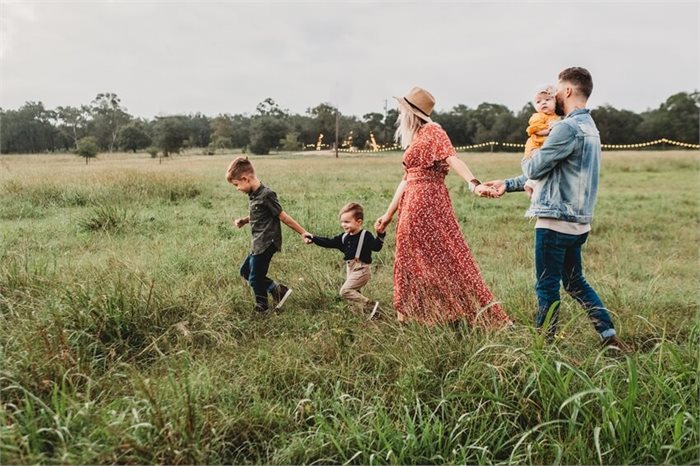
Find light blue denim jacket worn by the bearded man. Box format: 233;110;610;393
505;109;600;223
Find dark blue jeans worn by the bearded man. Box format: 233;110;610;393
535;228;616;339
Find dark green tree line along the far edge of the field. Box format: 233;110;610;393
0;91;700;157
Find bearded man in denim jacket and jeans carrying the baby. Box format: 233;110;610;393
486;67;627;351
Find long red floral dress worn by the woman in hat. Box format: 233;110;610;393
394;123;510;327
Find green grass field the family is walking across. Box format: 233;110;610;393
0;151;700;464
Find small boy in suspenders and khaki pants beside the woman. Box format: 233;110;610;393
304;202;385;319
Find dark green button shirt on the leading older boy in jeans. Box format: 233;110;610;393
248;184;282;254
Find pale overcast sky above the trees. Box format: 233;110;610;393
0;0;700;118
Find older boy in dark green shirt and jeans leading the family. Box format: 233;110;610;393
226;157;306;314
